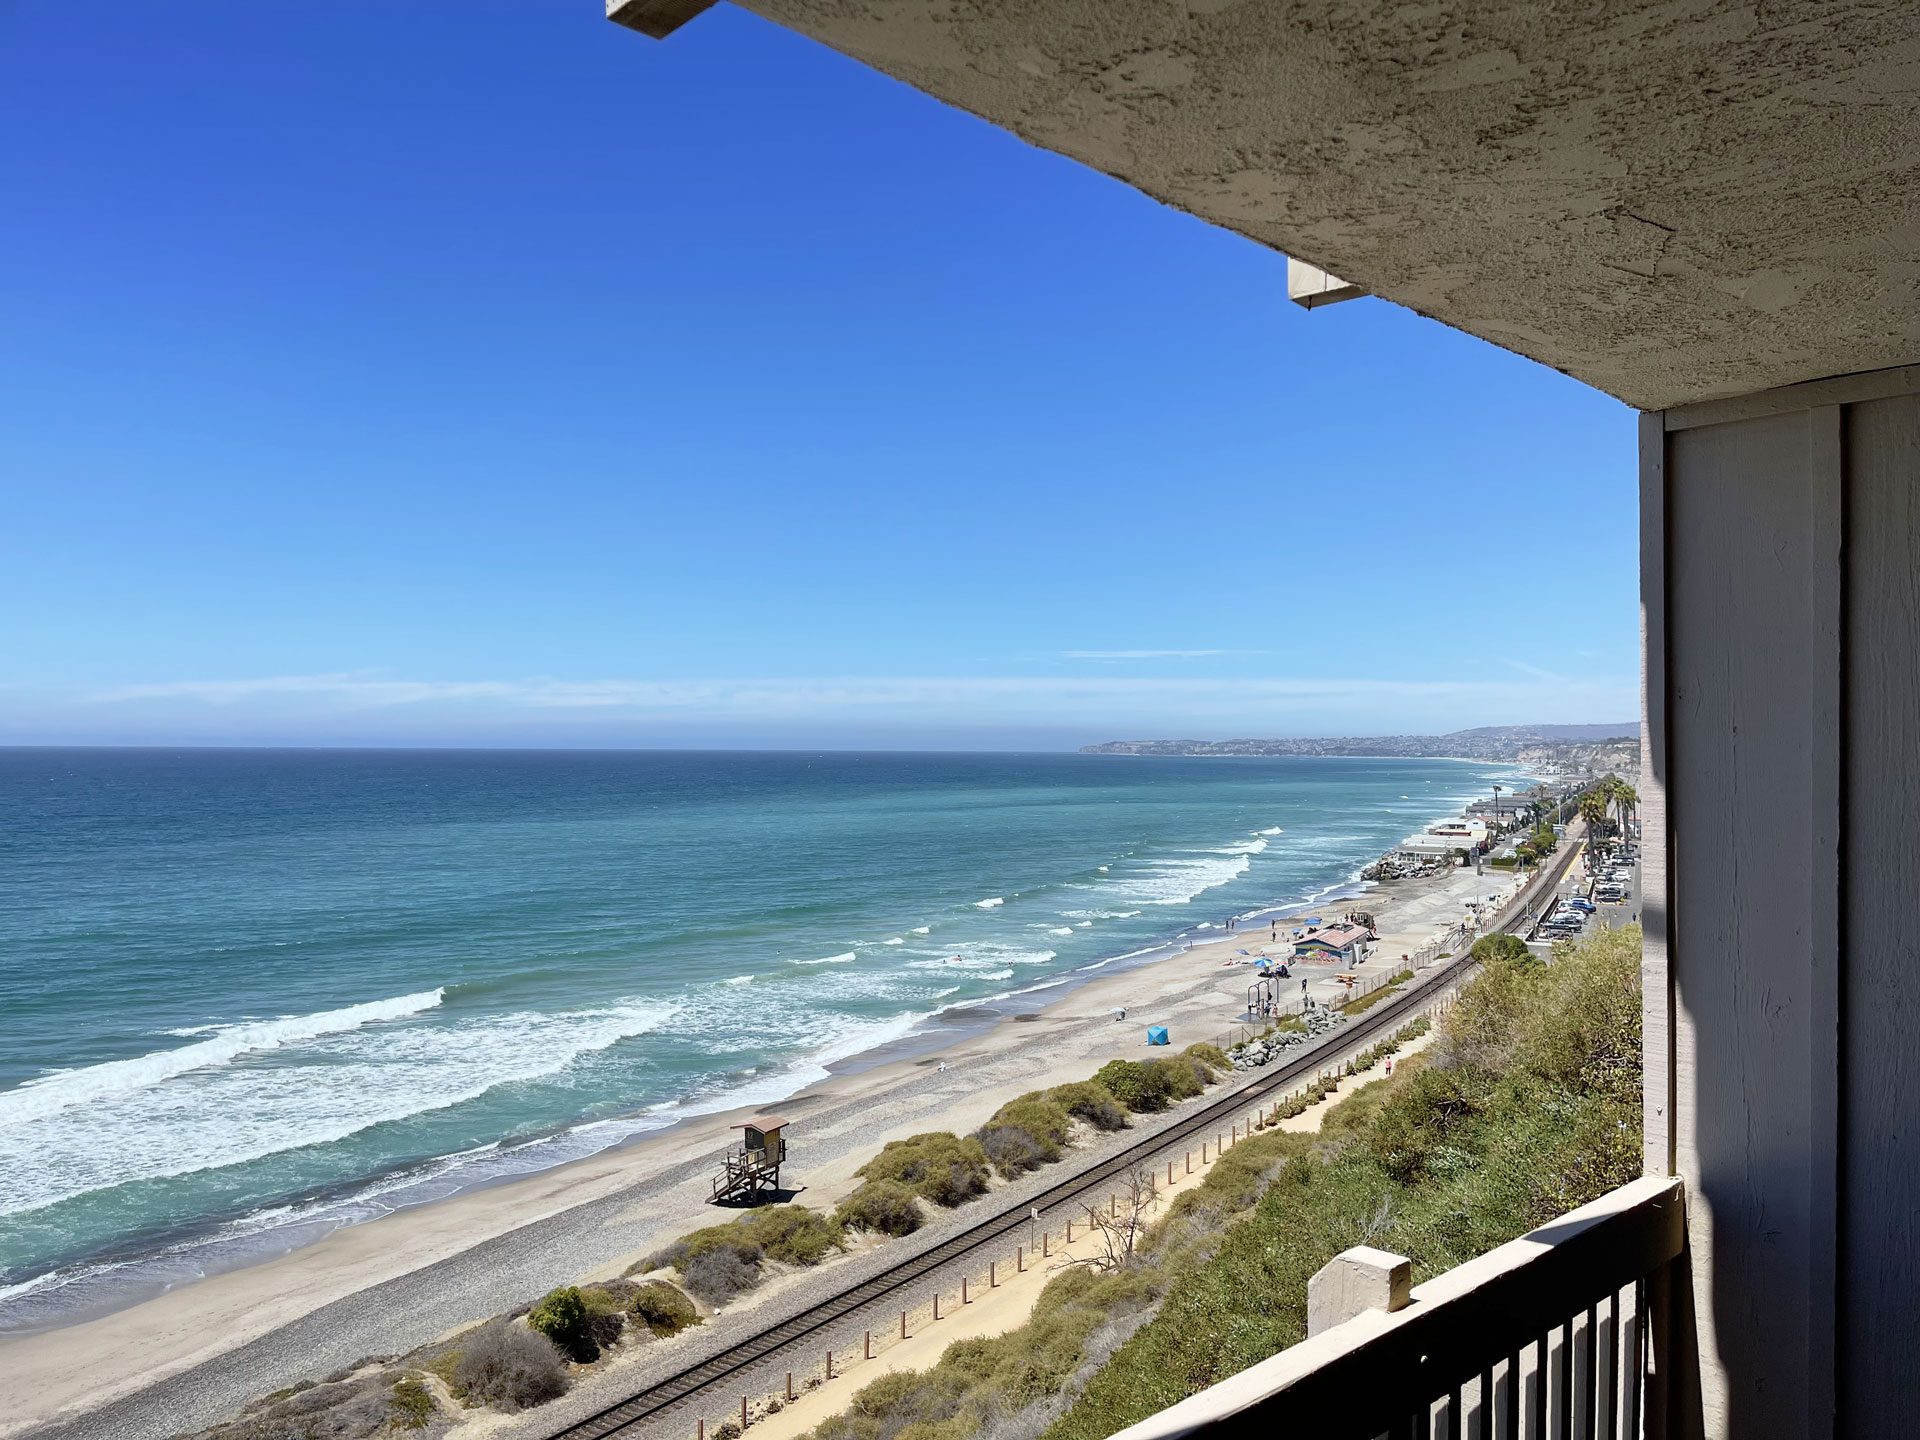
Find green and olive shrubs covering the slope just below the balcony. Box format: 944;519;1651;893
814;929;1640;1440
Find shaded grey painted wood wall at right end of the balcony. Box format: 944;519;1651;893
1642;369;1920;1436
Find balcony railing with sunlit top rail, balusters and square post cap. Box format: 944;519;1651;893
1116;1179;1686;1440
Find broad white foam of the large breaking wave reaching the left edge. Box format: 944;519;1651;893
0;1000;676;1215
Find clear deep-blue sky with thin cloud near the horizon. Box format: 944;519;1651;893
0;0;1638;747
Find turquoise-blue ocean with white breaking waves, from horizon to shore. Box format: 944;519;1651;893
0;751;1513;1327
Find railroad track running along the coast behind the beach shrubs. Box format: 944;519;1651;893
551;847;1578;1440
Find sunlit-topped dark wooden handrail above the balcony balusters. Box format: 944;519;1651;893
1114;1177;1686;1440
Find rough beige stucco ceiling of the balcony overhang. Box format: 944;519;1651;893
725;0;1920;409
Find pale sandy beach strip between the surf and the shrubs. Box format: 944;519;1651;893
0;856;1513;1440
